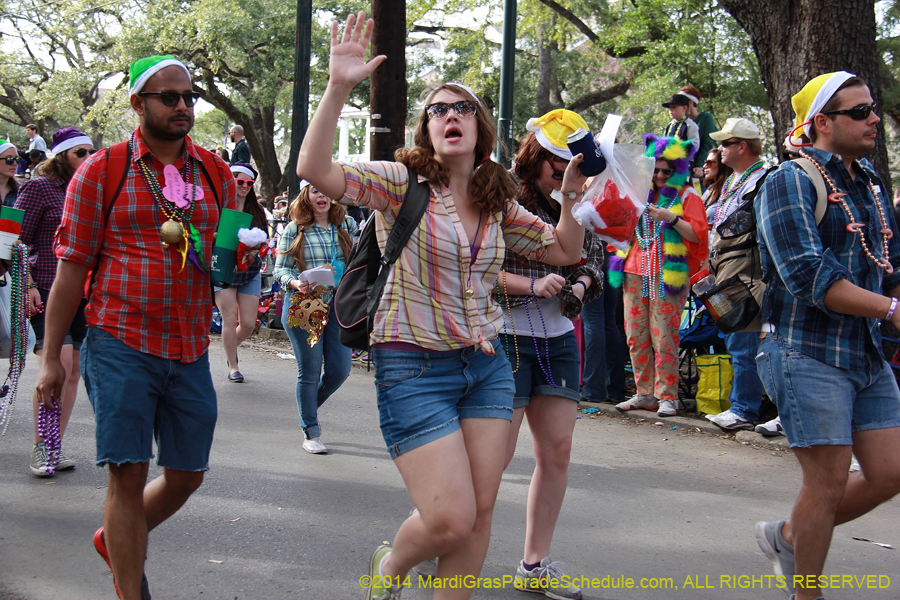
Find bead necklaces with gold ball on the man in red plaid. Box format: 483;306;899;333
128;133;206;274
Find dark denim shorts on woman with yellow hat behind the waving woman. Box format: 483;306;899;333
500;331;581;408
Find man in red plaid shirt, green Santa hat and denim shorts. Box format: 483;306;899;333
37;56;235;600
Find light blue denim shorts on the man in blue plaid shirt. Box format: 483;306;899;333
756;333;900;448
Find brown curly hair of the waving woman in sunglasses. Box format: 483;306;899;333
394;83;517;213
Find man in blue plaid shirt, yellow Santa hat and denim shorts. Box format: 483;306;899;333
755;71;900;600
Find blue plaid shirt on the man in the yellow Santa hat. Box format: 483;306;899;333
755;148;900;371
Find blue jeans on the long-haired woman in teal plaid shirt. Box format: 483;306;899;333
281;297;351;439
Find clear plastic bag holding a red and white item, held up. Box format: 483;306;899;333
572;114;656;250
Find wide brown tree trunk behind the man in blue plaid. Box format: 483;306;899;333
720;0;891;188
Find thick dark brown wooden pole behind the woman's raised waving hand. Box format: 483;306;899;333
369;0;407;160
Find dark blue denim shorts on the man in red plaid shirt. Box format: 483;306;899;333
81;327;217;471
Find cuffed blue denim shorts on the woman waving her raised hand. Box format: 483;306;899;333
372;339;515;458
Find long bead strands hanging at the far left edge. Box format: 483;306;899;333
0;244;28;433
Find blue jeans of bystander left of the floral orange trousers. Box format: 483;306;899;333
581;285;625;402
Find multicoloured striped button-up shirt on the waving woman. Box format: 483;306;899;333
341;162;556;351
